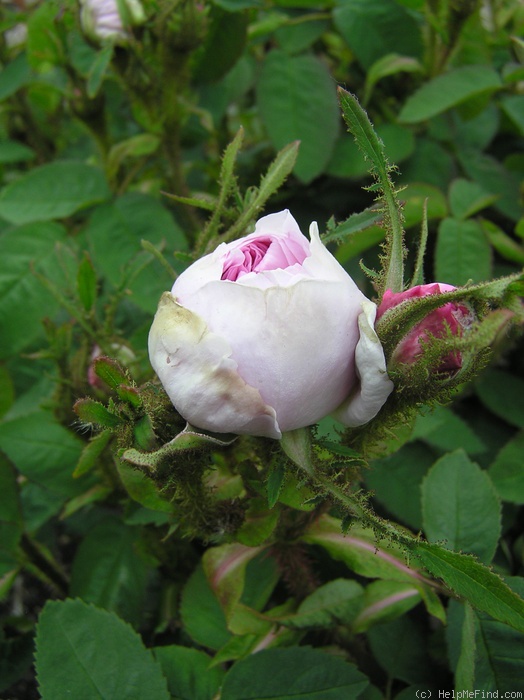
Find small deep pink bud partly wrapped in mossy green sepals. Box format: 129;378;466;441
377;282;474;374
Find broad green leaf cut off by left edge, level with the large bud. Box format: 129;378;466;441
0;223;65;357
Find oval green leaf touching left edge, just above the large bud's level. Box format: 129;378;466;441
0;161;110;224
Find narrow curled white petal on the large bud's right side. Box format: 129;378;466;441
333;300;394;428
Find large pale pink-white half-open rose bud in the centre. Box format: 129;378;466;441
149;210;393;438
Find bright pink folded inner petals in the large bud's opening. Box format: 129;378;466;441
221;236;307;282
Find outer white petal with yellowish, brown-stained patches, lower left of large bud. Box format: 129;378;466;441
149;292;282;439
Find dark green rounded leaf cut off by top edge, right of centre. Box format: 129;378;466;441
333;0;422;71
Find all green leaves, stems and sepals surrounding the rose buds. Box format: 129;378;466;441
0;0;524;700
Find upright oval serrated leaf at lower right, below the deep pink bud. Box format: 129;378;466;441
422;450;501;563
